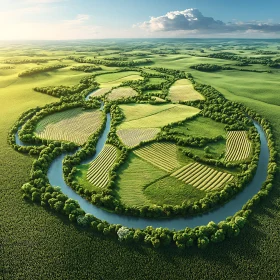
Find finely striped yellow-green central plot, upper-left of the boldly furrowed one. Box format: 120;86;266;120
134;143;180;172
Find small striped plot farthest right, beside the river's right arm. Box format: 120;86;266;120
225;131;251;161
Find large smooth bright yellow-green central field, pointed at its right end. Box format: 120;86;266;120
119;104;200;129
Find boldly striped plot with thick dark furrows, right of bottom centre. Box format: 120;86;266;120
171;163;234;191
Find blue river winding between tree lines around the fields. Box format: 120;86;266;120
15;93;269;230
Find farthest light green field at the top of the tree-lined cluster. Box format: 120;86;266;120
95;71;143;88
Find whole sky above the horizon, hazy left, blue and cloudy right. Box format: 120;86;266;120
0;0;280;40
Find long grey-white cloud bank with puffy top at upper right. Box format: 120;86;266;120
137;9;280;34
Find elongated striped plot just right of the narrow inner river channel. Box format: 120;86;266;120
87;145;118;188
